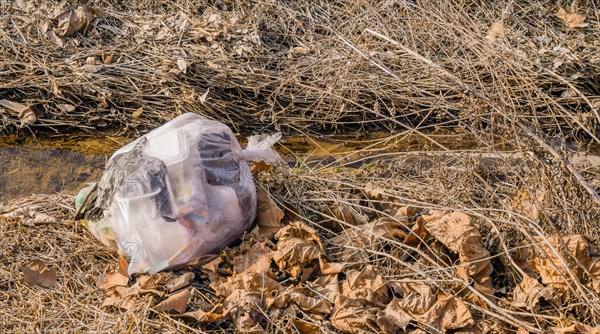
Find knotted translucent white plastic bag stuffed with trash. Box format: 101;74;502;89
79;113;281;274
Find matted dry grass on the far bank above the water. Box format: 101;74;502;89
0;1;600;137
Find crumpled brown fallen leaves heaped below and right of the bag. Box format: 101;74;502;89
81;185;600;333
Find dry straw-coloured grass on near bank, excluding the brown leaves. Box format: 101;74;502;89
0;153;600;332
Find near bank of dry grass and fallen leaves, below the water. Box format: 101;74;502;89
0;148;600;334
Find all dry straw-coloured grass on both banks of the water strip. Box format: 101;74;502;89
0;1;600;332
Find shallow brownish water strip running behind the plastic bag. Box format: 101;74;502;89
0;131;592;202
